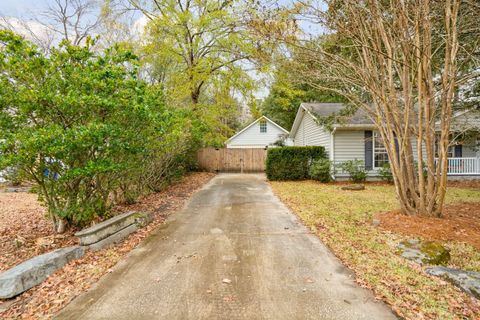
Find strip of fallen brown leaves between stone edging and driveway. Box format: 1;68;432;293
0;172;213;319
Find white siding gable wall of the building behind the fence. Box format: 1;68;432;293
227;120;285;148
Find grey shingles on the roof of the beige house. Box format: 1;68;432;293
302;103;373;125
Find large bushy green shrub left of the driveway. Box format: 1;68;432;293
0;31;197;230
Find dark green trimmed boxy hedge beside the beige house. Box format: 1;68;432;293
265;146;327;180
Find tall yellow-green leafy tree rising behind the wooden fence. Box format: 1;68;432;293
135;0;259;147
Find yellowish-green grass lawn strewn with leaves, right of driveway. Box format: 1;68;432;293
271;181;480;319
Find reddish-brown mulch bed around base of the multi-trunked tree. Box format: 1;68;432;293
376;202;480;250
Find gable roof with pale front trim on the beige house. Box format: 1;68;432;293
290;102;374;138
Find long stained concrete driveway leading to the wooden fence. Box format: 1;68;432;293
58;174;396;320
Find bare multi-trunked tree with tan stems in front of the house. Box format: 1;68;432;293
299;0;478;216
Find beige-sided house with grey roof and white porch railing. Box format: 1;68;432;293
290;103;480;178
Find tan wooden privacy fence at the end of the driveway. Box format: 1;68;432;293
197;148;267;173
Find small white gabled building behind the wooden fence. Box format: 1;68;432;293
225;116;291;148
